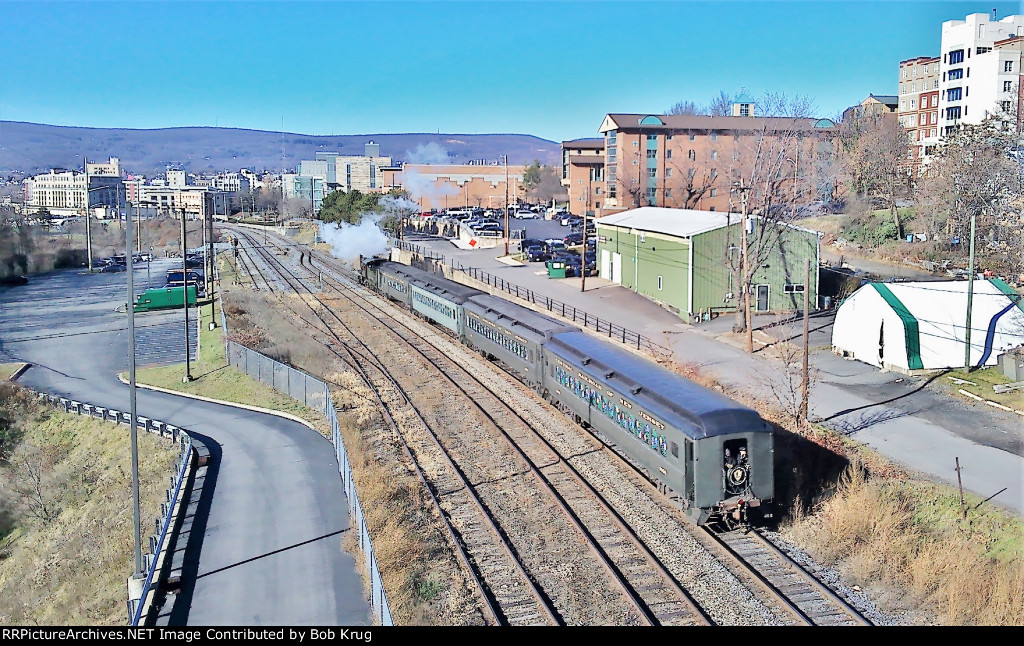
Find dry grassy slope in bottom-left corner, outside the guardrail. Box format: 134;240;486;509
0;384;178;626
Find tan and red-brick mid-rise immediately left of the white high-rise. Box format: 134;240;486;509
896;56;941;168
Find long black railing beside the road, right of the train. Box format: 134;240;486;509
391;239;670;354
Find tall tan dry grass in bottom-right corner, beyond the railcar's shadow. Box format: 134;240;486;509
788;464;1024;626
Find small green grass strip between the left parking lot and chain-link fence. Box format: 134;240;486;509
135;268;331;437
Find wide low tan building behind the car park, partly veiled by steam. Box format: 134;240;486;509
381;164;525;211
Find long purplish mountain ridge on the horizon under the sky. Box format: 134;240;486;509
0;121;561;176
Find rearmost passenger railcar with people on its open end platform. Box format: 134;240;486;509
544;332;774;523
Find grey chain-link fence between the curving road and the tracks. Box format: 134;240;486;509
221;341;394;626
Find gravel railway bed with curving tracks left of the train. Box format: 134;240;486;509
222;229;868;625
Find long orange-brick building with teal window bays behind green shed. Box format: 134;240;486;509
597;110;836;216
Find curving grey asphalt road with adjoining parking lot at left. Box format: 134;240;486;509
0;264;371;626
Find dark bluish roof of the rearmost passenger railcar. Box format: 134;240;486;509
545;332;770;439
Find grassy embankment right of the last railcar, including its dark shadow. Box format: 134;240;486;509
675;358;1024;626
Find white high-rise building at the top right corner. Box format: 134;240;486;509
939;13;1024;135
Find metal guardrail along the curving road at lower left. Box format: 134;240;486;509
40;393;193;626
